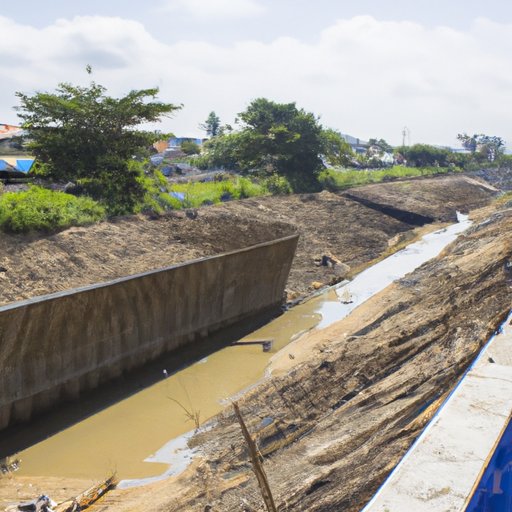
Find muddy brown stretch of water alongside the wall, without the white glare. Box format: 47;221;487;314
8;293;326;479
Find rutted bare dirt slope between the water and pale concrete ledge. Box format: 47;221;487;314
97;205;512;512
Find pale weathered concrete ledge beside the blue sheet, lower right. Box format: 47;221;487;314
364;316;512;512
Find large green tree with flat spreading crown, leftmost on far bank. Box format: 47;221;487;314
15;77;181;213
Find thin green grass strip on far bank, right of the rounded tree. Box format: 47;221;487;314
319;165;460;191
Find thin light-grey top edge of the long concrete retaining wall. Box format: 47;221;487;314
0;233;299;313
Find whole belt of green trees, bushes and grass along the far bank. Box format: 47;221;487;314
7;74;512;236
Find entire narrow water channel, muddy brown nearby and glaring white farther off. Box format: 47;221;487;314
3;217;470;481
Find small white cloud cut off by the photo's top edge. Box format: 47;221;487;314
163;0;265;20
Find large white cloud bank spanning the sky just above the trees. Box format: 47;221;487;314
0;14;512;147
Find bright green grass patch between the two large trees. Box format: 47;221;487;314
170;177;268;209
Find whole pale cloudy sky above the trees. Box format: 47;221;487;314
0;0;512;149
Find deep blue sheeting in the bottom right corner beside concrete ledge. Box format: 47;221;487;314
466;421;512;512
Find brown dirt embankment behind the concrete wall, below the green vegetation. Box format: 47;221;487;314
0;176;495;305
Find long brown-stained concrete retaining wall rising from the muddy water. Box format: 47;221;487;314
0;235;298;429
